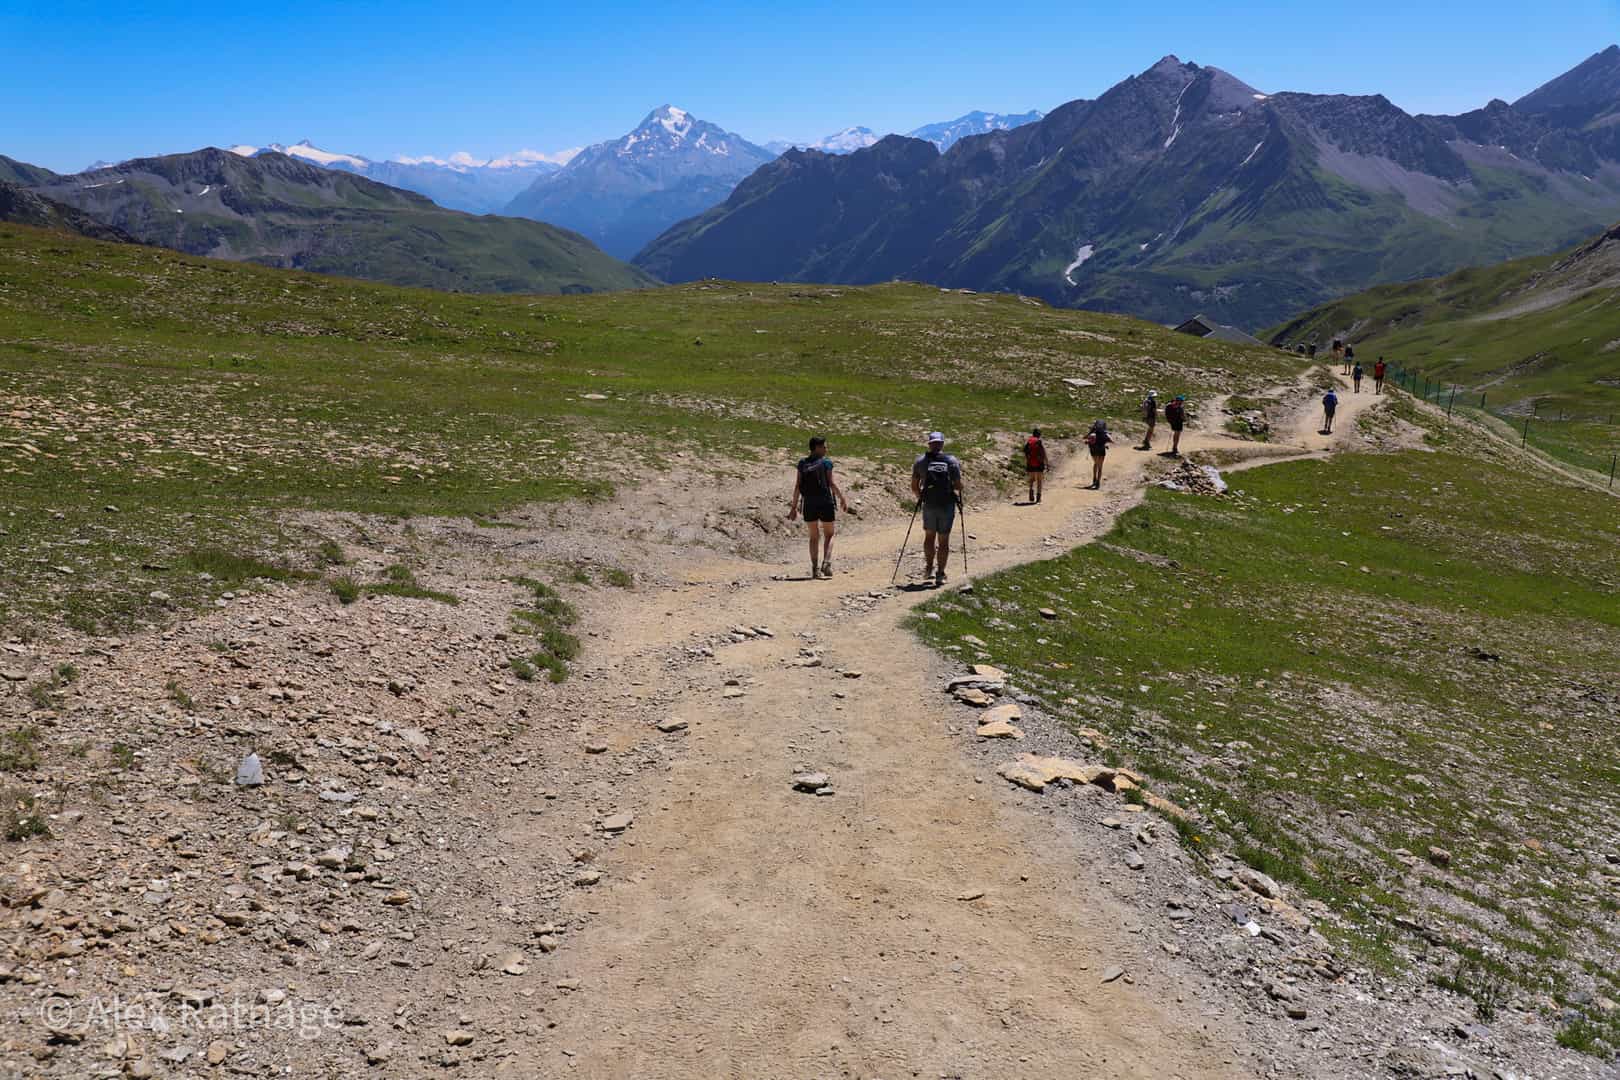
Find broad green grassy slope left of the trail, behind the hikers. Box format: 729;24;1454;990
0;227;1296;625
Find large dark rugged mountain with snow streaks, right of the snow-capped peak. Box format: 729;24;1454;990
637;53;1620;327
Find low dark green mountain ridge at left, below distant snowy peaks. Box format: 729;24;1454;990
34;149;650;291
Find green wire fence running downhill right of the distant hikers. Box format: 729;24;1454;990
1369;363;1620;487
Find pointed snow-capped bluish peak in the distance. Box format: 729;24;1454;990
505;105;776;259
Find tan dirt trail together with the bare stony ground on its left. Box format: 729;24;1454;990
0;372;1379;1080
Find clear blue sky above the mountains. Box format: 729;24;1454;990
0;0;1620;170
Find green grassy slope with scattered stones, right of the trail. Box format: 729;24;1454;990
917;440;1620;1048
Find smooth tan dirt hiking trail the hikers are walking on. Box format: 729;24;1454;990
424;367;1374;1077
